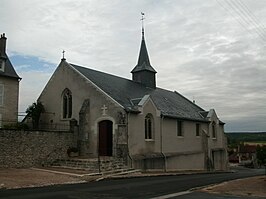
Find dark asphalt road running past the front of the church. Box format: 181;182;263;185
0;169;264;199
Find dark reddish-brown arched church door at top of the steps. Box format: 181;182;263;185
98;120;113;156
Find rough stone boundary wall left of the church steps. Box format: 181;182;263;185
0;129;77;168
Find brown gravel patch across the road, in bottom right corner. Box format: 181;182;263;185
202;176;266;198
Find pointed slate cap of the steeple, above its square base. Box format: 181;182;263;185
131;27;157;73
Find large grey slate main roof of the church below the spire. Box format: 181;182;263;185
70;64;207;121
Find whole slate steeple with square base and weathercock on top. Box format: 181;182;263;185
131;13;156;88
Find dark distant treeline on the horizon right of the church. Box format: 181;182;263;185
225;132;266;144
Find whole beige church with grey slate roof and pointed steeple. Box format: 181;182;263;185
34;28;227;171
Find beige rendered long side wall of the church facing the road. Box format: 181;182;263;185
128;95;227;171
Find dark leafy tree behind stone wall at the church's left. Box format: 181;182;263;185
26;101;44;129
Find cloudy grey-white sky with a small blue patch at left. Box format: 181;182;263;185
0;0;266;132
